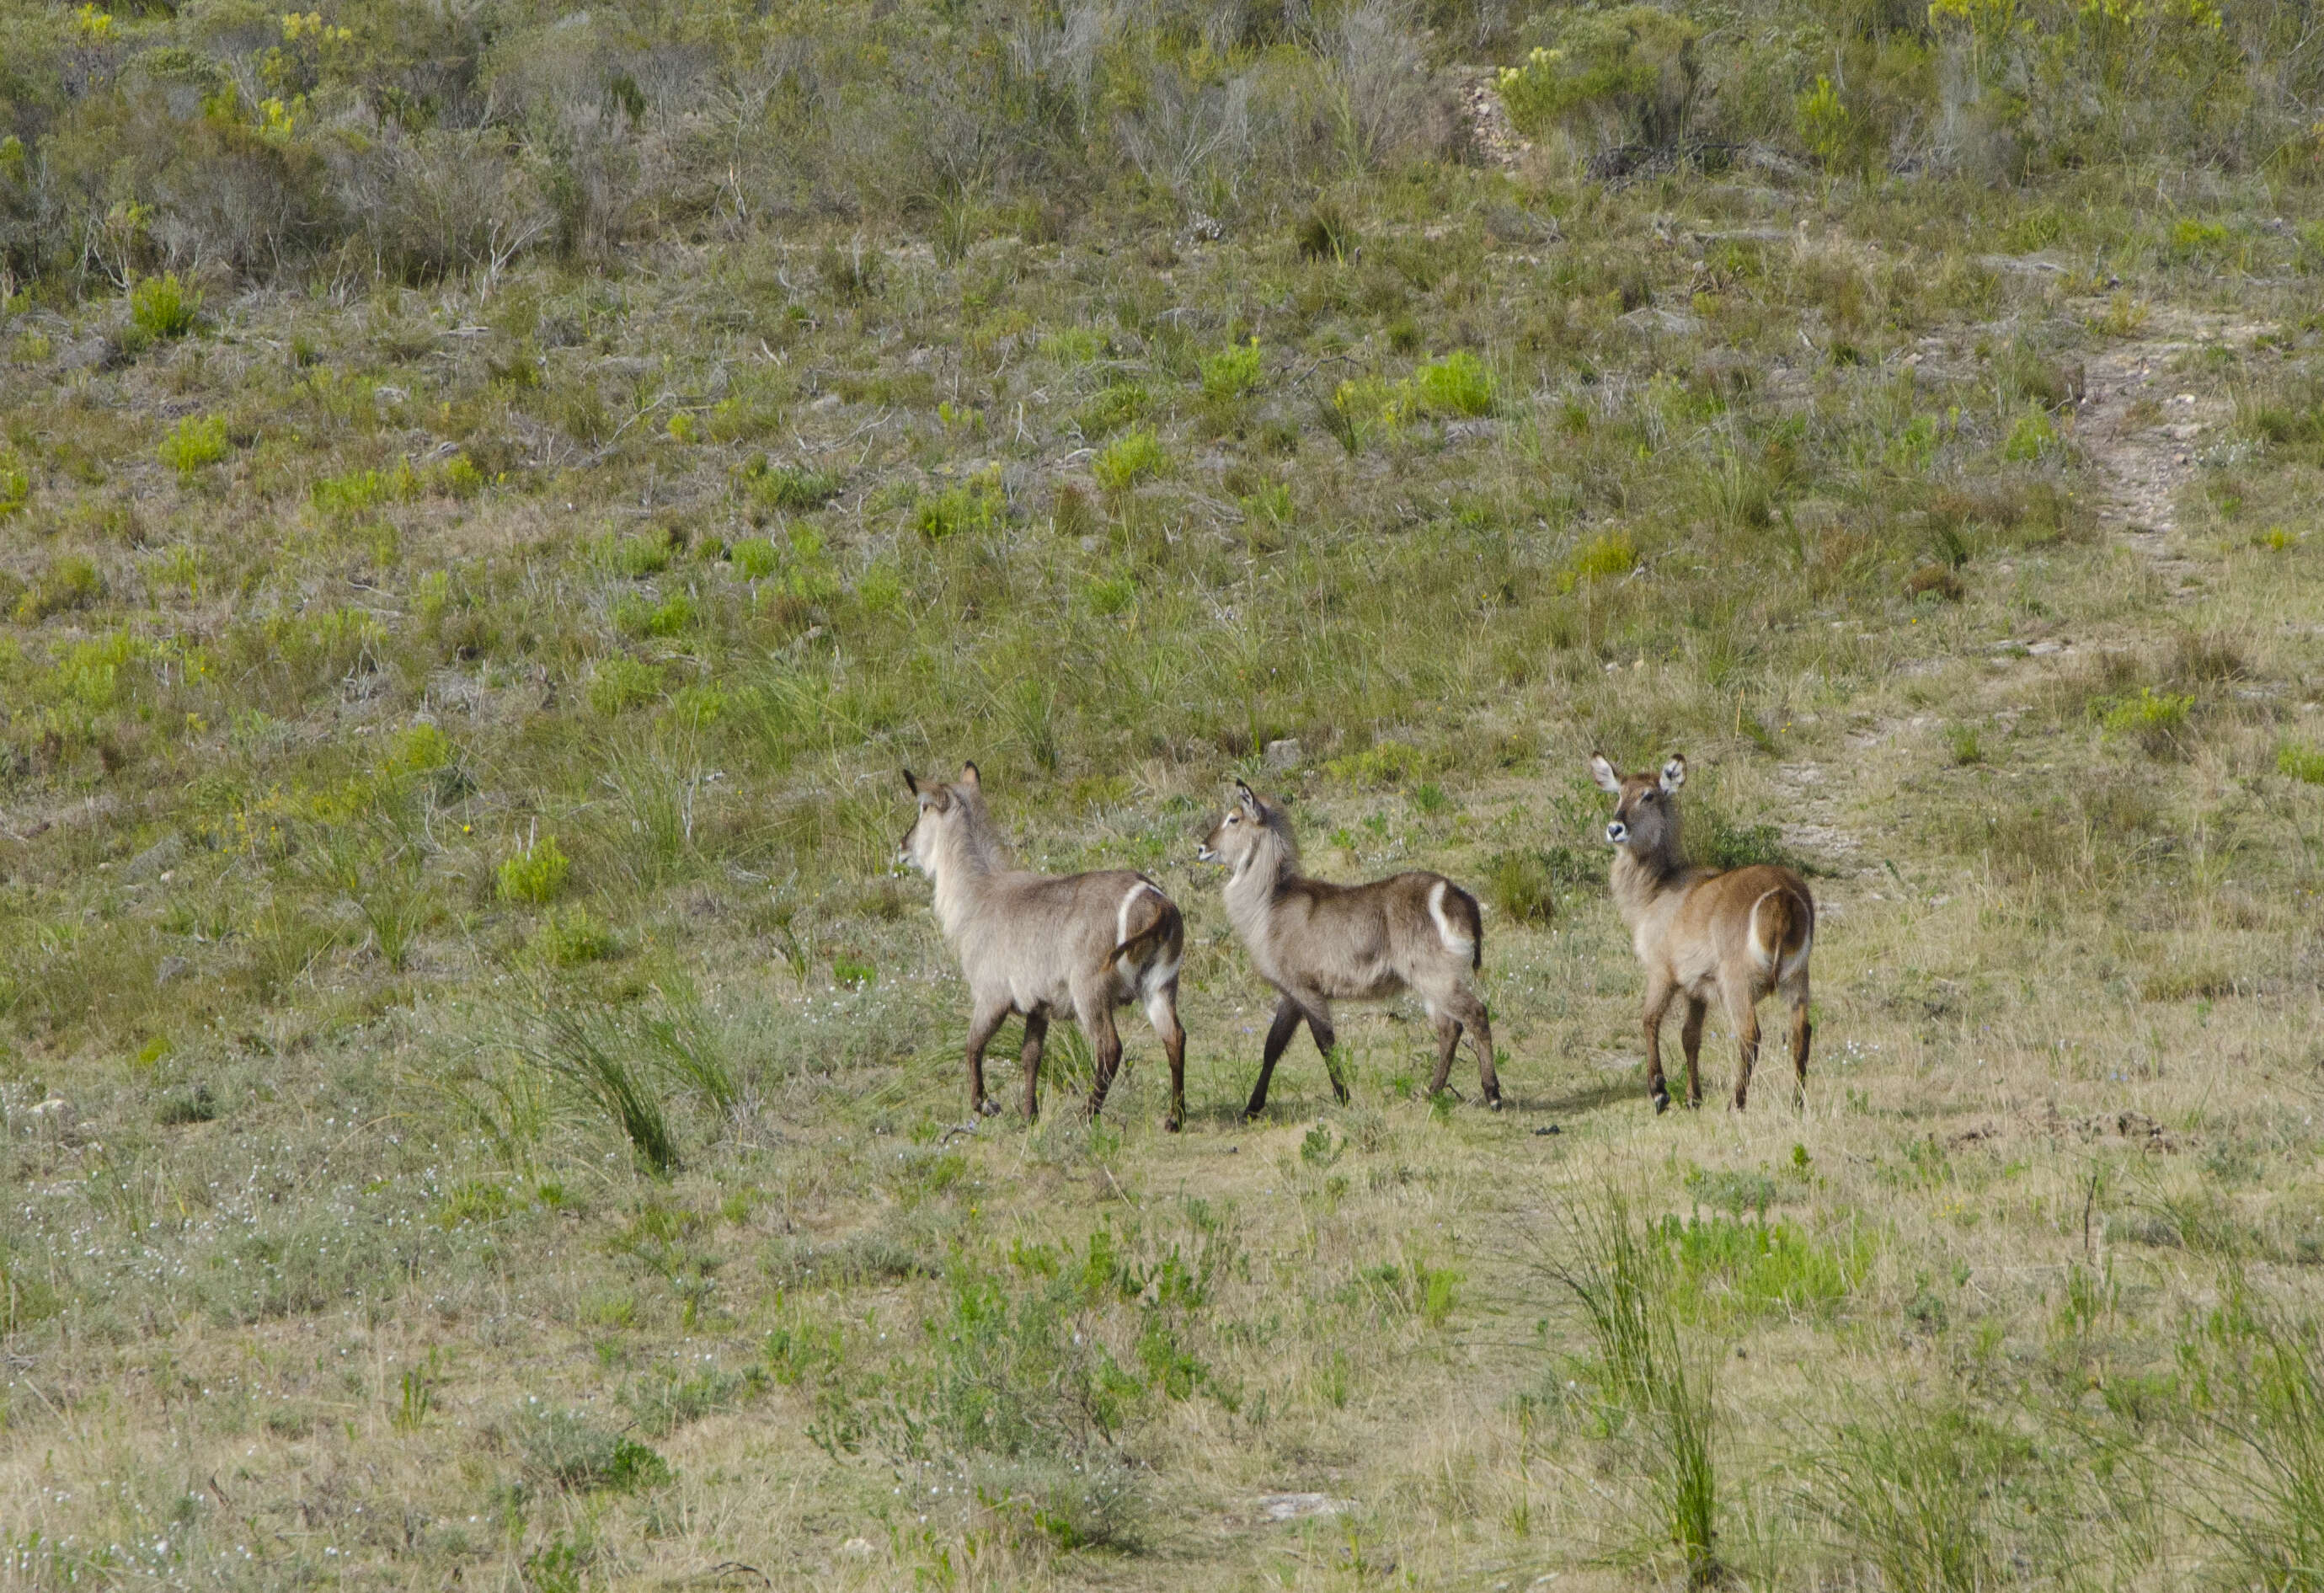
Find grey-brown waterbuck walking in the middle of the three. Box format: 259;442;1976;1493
1194;782;1501;1116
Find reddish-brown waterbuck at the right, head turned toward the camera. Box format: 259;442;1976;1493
1589;753;1815;1112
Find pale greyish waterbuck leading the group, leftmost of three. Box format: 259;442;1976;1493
901;762;1185;1132
